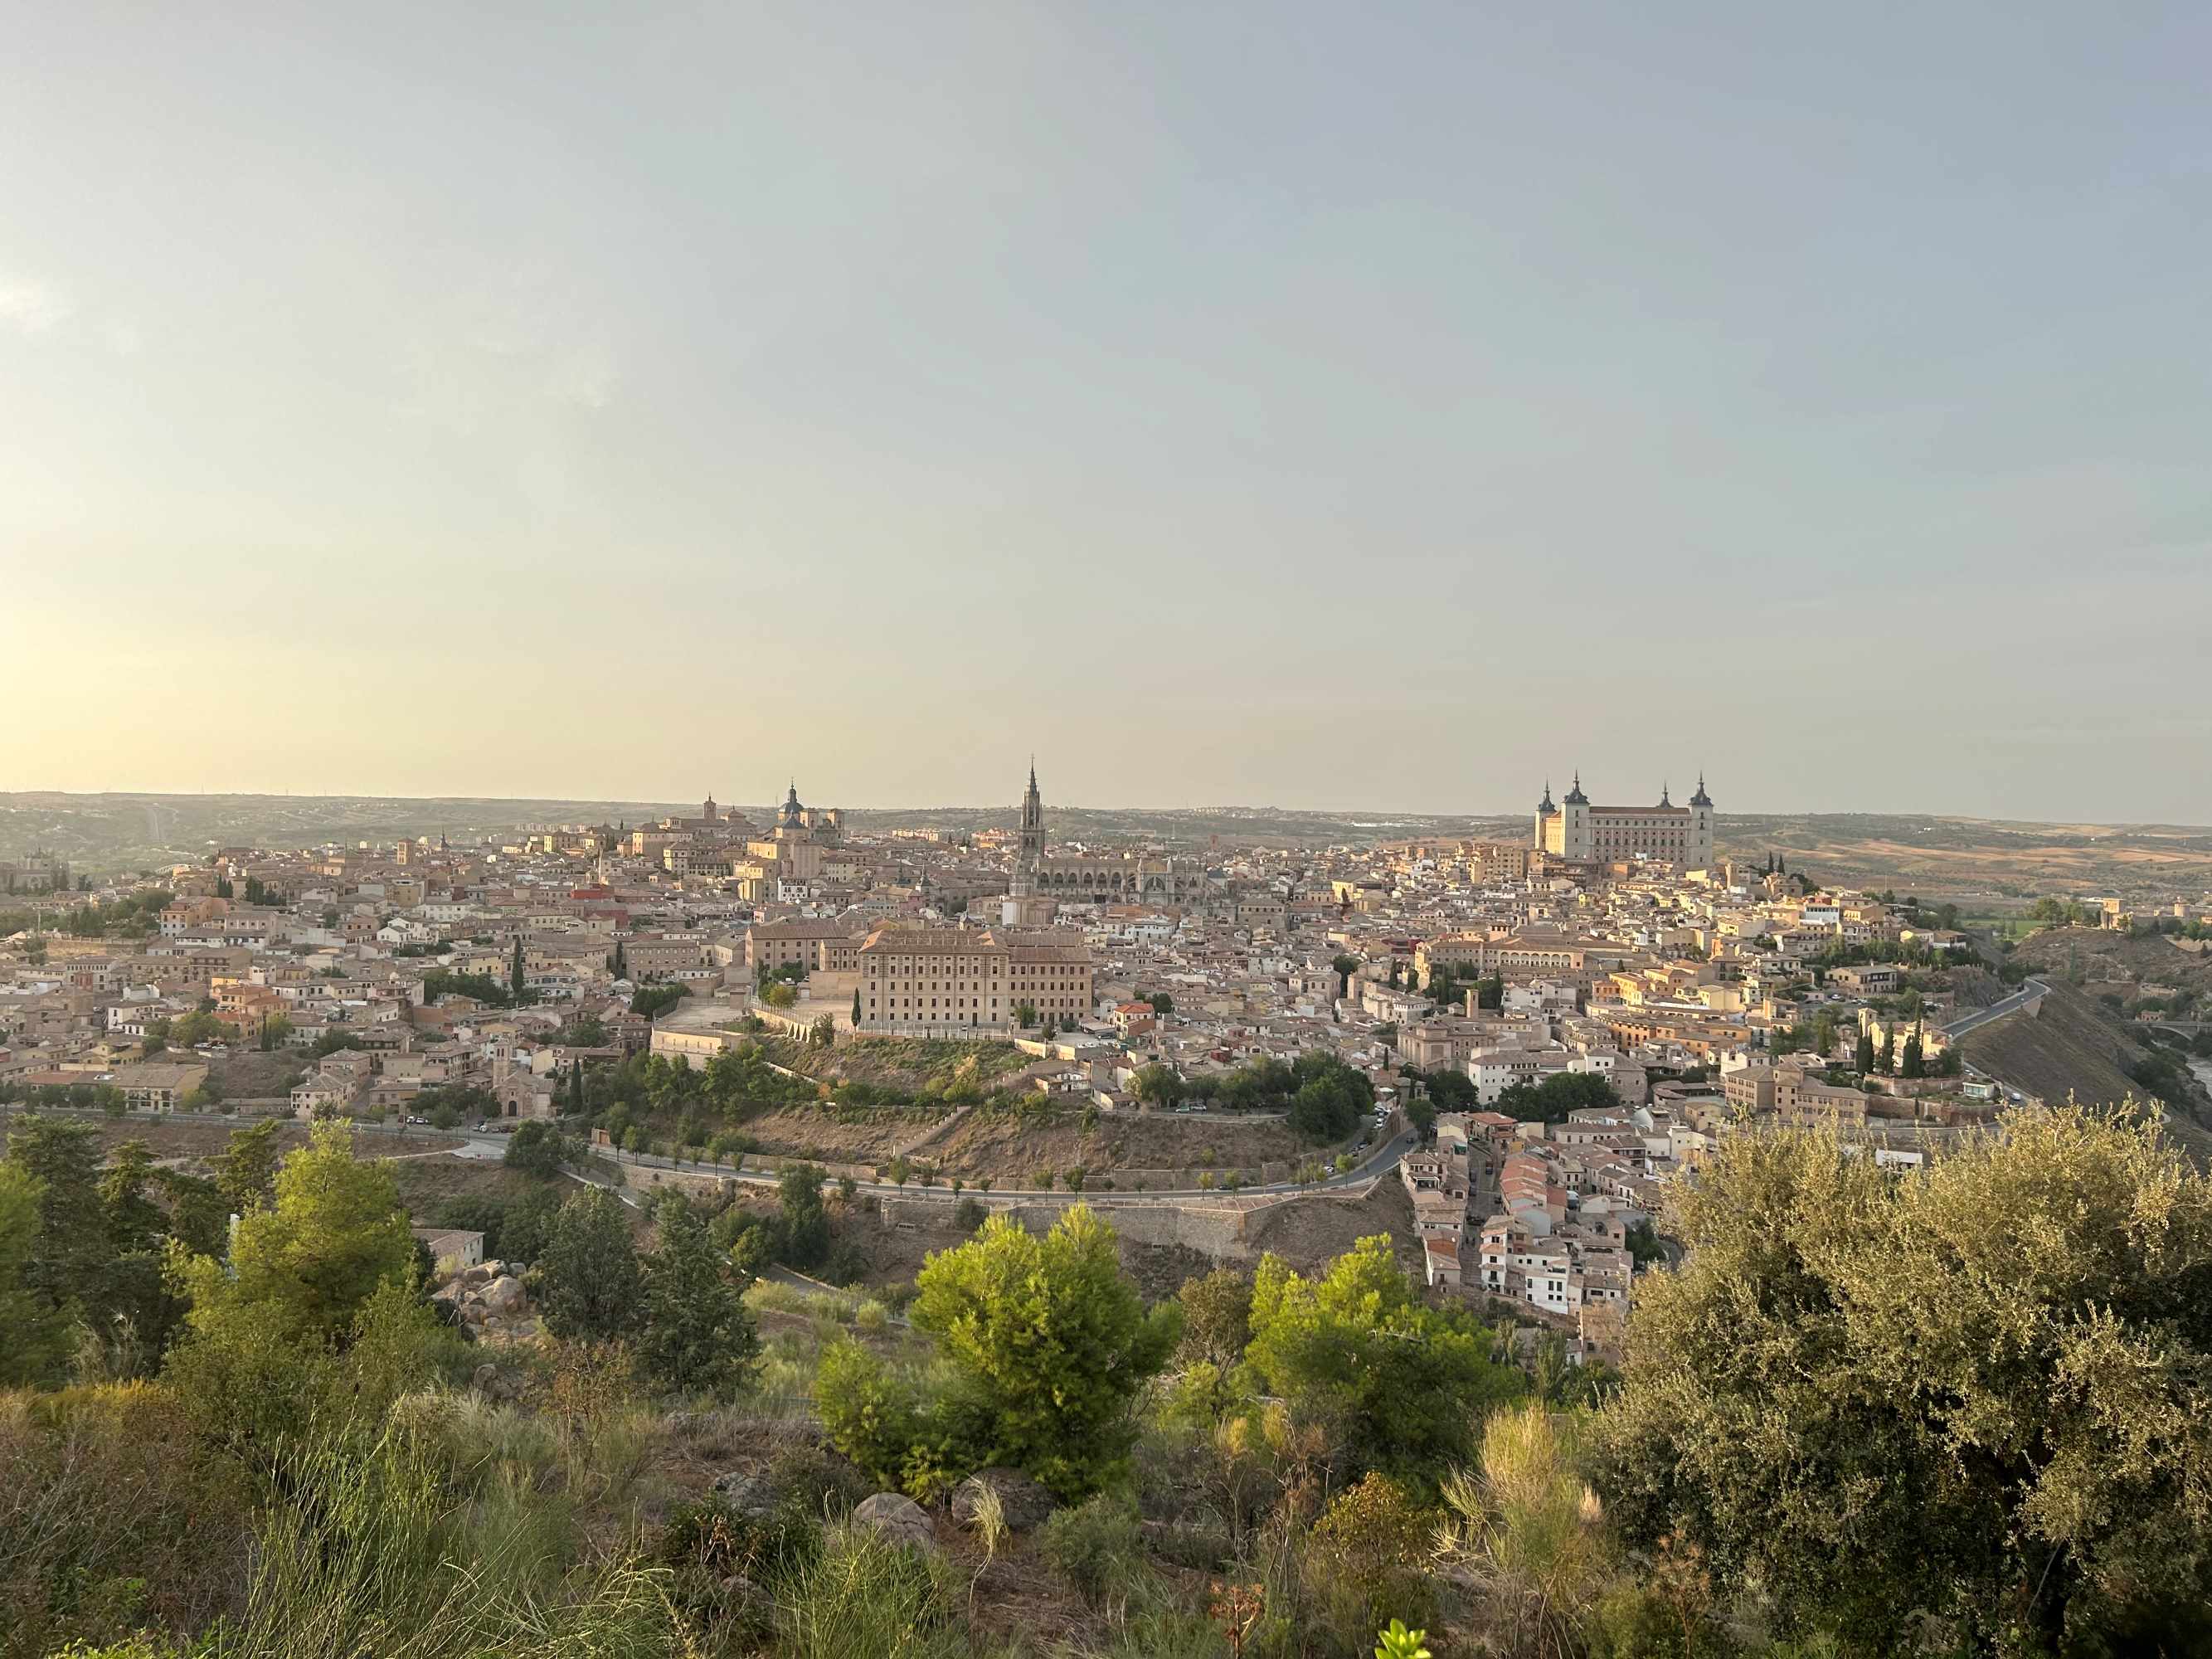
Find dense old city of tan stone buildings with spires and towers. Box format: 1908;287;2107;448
0;767;2194;1347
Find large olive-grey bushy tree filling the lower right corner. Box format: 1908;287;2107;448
1597;1108;2212;1652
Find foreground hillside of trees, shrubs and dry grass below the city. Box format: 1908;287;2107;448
0;1111;2212;1659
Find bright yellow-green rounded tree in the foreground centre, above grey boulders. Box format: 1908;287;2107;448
913;1204;1179;1497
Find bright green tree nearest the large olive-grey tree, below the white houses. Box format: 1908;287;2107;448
1246;1234;1519;1480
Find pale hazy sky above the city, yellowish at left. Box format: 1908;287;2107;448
0;0;2212;823
